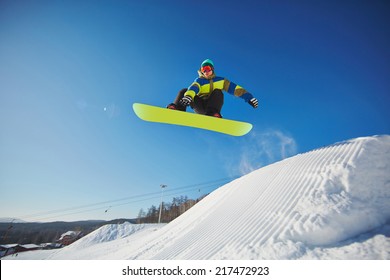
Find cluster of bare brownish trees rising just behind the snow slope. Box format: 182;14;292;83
136;195;206;224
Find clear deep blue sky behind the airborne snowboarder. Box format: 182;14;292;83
0;0;390;221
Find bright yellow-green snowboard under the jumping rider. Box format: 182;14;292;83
133;103;252;136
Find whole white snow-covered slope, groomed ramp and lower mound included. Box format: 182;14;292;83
6;135;390;259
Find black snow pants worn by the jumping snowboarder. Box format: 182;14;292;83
173;88;224;116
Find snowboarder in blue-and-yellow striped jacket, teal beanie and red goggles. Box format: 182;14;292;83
167;59;259;118
